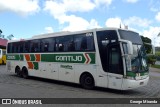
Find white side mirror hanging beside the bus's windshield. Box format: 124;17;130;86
120;40;133;55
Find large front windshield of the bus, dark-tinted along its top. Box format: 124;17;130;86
119;30;148;72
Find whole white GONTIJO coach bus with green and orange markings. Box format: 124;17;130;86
7;28;149;90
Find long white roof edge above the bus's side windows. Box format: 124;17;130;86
8;28;133;43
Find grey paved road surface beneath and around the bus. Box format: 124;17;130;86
0;65;160;106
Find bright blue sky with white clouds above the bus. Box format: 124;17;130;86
0;0;160;46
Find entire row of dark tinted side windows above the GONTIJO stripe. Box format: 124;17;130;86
7;33;95;53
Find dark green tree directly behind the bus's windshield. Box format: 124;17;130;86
141;36;152;54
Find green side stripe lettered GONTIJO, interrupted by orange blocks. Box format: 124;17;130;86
7;53;95;64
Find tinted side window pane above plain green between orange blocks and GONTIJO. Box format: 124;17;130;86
41;38;55;52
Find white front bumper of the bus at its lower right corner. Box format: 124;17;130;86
122;76;149;90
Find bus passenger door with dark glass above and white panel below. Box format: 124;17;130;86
107;45;123;89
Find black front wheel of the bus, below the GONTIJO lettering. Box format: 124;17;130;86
80;74;95;89
